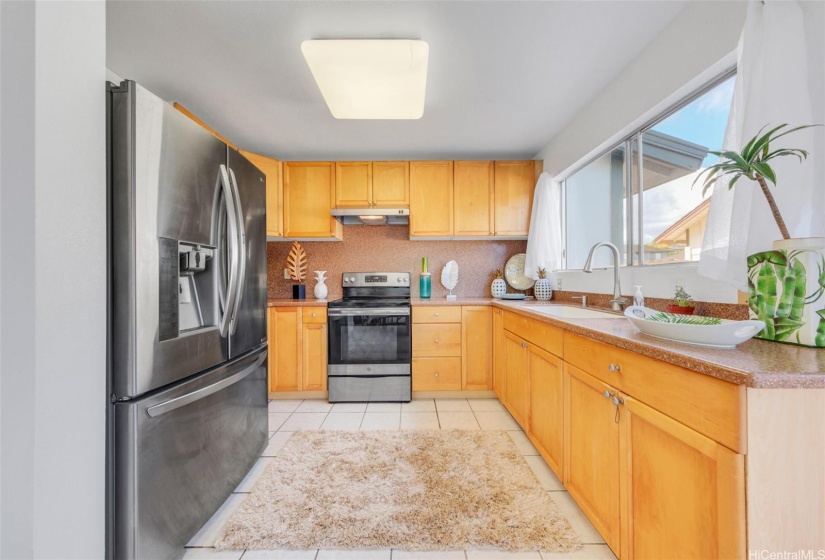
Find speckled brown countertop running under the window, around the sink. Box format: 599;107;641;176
493;300;825;389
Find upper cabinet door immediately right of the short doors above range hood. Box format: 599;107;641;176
410;161;453;237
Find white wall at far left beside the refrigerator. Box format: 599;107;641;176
0;1;106;559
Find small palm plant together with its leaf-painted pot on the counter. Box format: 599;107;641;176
694;124;825;347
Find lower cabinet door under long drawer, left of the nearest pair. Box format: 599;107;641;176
564;364;620;555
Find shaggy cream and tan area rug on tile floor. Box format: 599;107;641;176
215;431;581;552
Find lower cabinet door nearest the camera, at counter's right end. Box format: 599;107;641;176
621;396;747;559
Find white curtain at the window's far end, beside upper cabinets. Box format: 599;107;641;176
524;173;562;279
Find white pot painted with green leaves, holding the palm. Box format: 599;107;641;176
748;237;825;348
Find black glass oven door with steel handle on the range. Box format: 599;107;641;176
327;307;412;376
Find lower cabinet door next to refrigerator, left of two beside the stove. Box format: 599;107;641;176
269;307;301;391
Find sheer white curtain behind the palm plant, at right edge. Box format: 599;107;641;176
697;0;825;290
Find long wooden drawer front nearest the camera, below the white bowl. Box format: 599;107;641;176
564;332;745;453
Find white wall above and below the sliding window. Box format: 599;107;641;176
537;1;745;303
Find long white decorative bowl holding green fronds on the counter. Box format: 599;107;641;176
624;305;765;348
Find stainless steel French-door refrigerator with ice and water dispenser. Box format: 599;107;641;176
107;81;268;559
